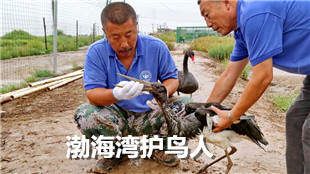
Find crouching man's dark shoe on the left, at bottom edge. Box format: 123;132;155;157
91;158;122;173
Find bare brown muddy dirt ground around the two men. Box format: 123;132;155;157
1;44;303;174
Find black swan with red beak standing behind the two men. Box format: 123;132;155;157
177;50;199;97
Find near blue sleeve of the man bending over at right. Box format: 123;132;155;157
243;13;283;66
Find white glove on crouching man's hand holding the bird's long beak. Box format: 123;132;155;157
112;81;146;100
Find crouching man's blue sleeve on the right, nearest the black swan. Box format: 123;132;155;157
158;44;178;82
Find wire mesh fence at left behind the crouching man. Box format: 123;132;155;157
0;0;106;92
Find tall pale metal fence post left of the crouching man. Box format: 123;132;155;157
52;0;57;75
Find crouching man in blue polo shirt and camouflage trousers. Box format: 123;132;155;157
74;2;184;173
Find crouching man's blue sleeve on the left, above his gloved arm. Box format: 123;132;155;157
83;48;107;91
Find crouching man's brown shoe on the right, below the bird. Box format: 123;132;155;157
151;150;180;167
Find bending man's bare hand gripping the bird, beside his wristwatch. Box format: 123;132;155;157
211;106;232;133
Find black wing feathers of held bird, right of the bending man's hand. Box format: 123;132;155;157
231;119;268;150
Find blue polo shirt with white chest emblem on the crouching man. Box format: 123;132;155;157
83;35;178;113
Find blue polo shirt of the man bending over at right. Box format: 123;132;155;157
230;0;310;75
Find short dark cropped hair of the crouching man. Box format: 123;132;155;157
101;2;137;28
